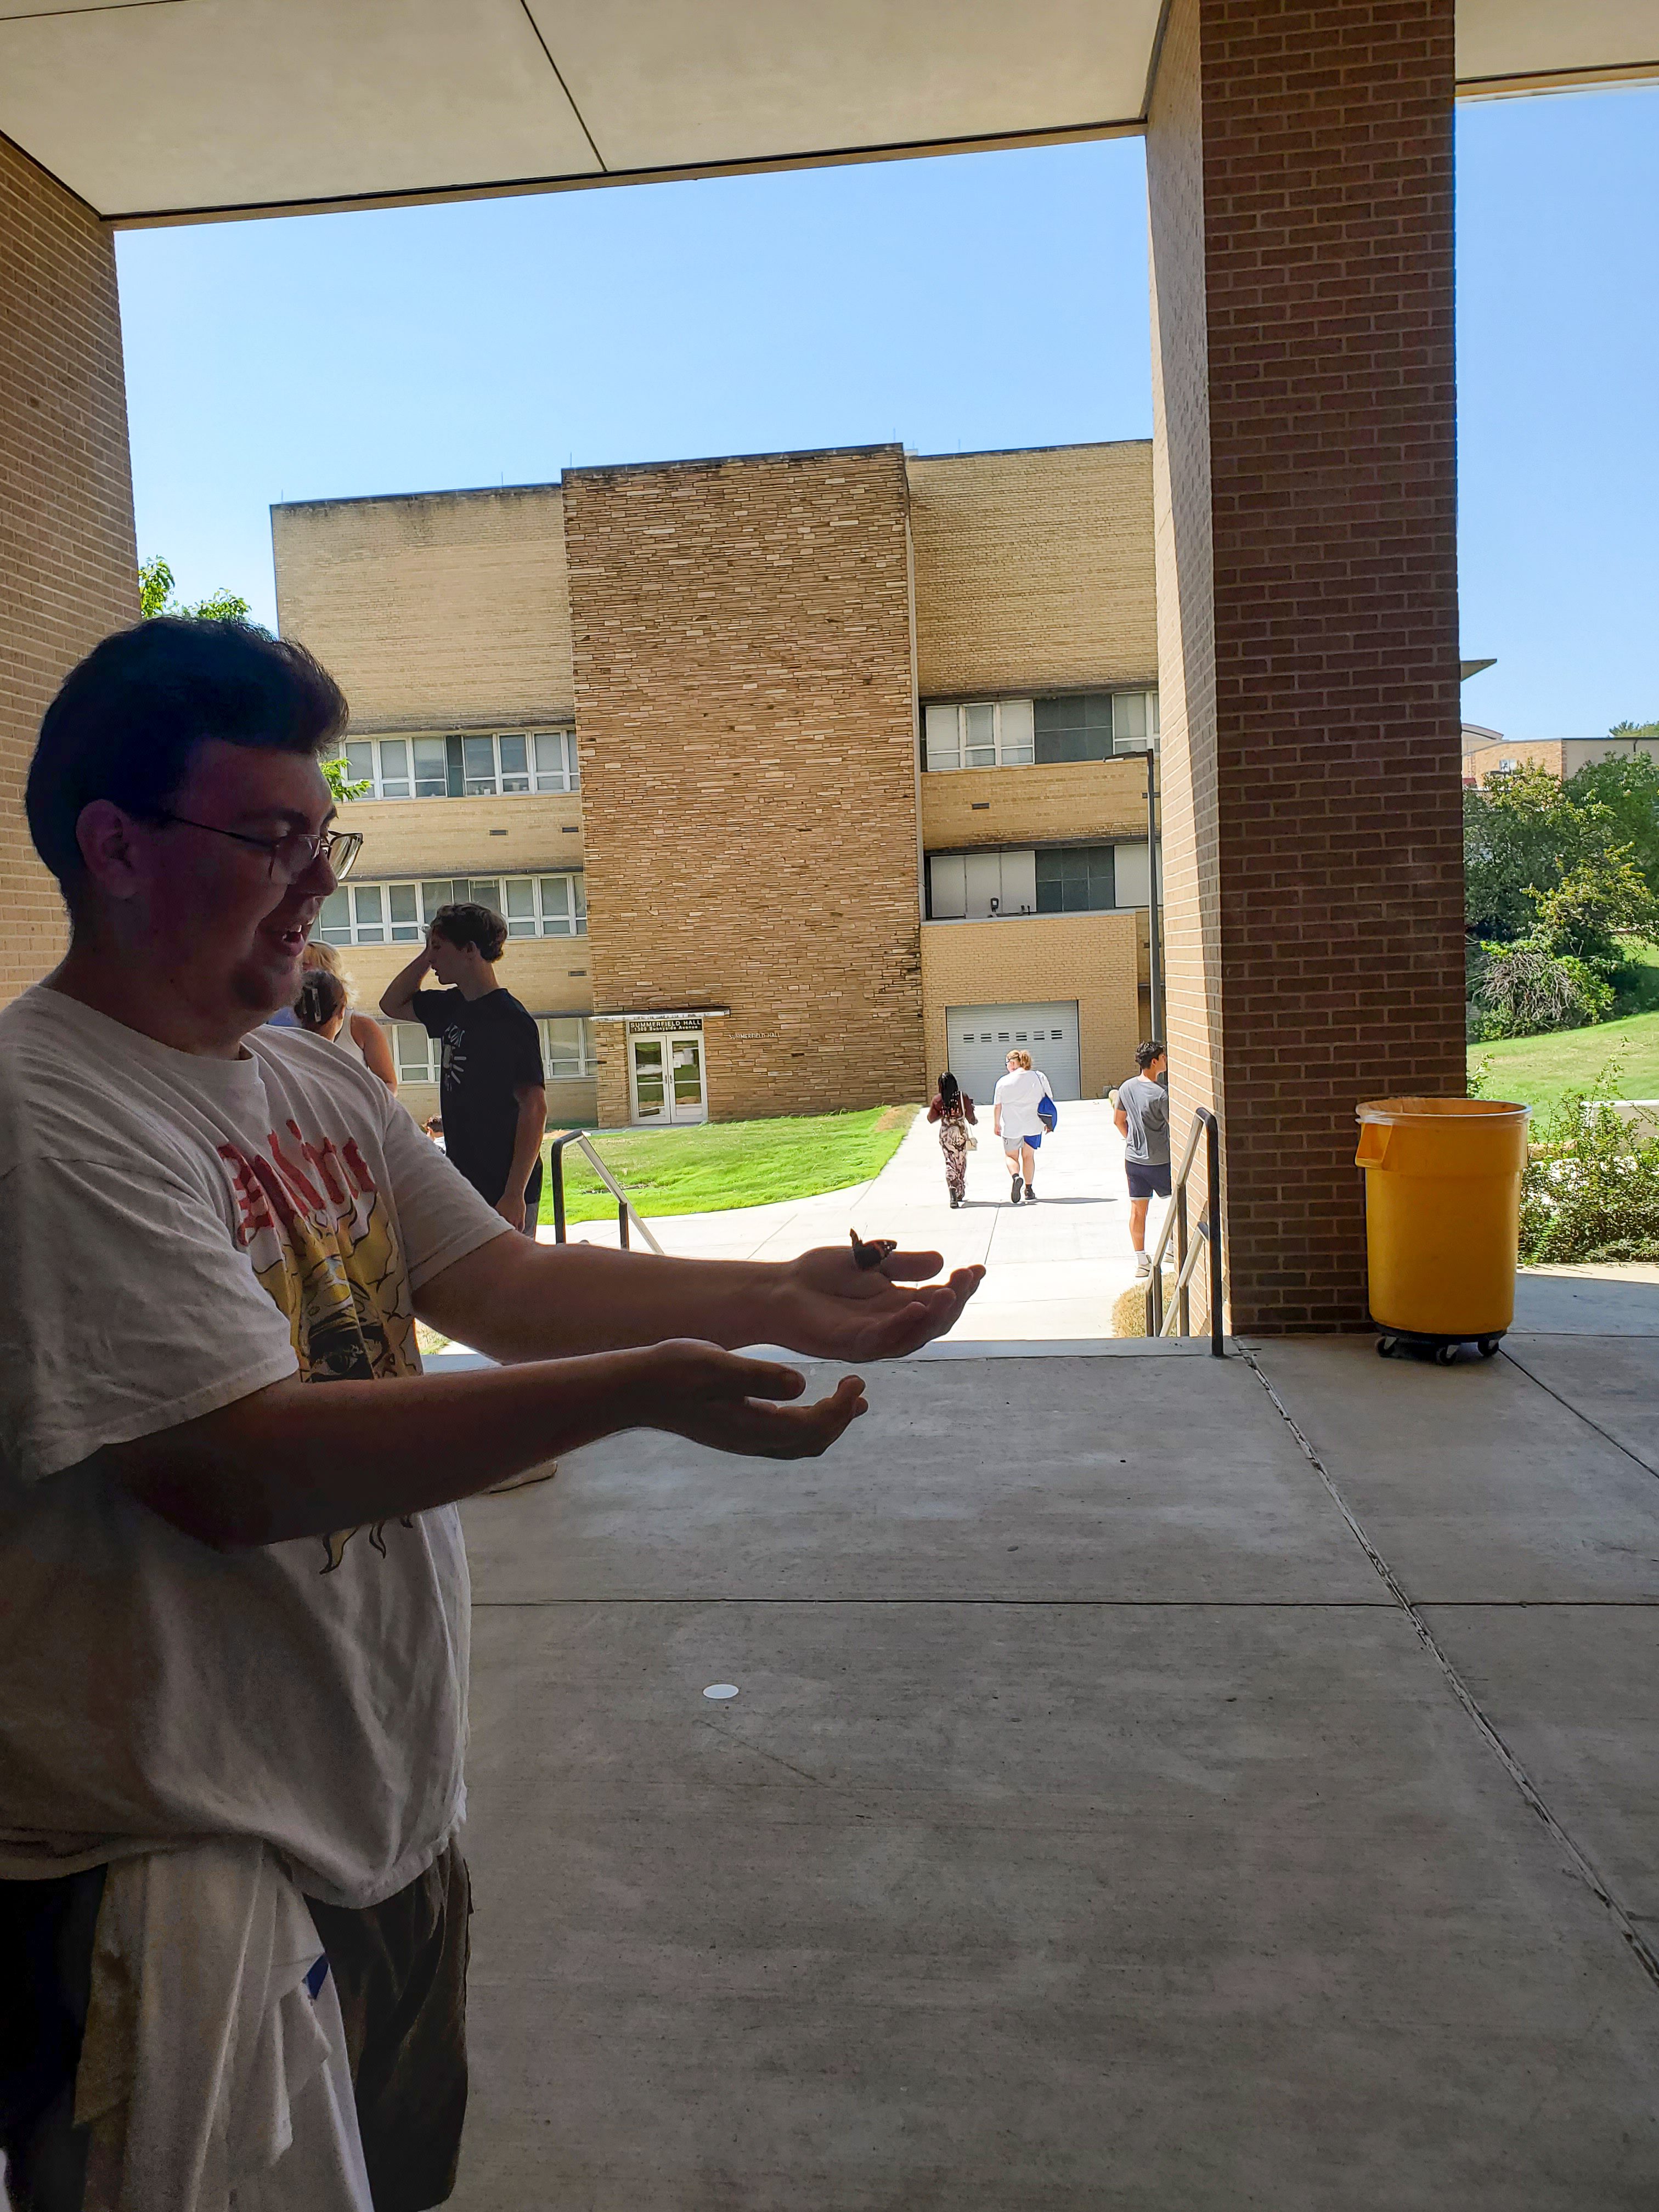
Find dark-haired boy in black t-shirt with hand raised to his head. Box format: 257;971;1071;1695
381;905;546;1237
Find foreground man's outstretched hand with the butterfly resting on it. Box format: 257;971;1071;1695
754;1245;984;1361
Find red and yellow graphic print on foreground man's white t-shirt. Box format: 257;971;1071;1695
219;1119;418;1575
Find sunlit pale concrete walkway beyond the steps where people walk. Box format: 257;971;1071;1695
542;1099;1161;1350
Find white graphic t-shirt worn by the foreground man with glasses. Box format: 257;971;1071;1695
0;986;506;1905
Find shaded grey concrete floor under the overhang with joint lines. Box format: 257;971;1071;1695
456;1285;1659;2212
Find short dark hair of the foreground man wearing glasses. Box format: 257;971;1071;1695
24;615;347;894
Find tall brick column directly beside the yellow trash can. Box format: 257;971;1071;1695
1146;0;1464;1331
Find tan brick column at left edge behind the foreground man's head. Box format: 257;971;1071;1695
0;137;137;1000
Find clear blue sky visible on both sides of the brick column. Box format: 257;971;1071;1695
117;91;1659;737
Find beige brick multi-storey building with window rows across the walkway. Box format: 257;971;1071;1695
272;442;1159;1126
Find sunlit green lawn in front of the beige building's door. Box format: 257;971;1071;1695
542;1106;920;1228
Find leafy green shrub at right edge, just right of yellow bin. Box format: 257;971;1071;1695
1520;1055;1659;1265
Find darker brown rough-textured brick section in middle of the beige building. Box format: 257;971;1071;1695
564;447;924;1121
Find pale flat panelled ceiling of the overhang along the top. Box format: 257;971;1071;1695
0;0;1659;221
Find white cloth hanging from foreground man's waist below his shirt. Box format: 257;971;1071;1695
75;1838;371;2212
